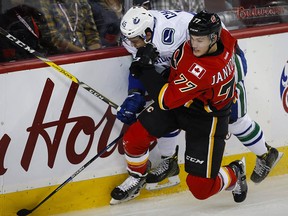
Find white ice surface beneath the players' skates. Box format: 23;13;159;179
57;175;288;216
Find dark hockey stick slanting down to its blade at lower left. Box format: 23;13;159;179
17;133;123;216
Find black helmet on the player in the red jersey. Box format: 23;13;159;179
188;11;222;39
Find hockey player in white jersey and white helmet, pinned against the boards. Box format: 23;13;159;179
117;4;283;190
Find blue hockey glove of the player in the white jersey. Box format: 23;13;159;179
116;92;146;125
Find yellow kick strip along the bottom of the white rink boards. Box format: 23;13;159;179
0;146;288;216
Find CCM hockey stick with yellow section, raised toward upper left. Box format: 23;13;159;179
0;27;119;109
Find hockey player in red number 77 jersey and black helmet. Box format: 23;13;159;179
111;12;248;203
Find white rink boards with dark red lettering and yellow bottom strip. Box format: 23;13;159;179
0;33;288;216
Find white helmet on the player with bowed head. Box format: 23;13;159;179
120;6;154;40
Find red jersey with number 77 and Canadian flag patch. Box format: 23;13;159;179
158;29;236;112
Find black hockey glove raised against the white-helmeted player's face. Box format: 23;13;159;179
129;43;159;78
